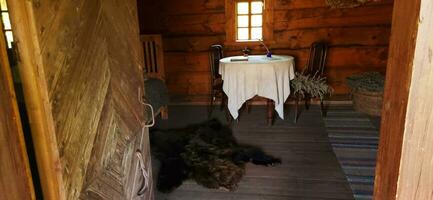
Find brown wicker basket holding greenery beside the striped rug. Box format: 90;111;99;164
352;90;383;116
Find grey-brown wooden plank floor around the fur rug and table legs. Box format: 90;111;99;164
152;106;353;200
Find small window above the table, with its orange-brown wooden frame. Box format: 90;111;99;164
225;0;274;45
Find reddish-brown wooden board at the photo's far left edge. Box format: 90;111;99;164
0;23;35;200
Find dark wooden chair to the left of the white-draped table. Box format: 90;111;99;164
208;44;227;118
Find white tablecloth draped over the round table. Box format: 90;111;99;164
219;55;295;119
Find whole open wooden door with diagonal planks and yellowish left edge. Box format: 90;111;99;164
9;0;152;200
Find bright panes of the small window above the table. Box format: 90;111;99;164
236;0;263;41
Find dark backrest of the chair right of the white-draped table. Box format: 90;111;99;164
304;42;328;75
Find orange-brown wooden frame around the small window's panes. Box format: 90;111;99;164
224;0;274;45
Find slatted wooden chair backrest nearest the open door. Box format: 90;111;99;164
140;35;165;80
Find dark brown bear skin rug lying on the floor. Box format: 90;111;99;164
150;119;281;193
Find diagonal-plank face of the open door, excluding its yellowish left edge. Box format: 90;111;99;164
17;0;151;199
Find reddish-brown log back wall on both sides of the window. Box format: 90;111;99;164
138;0;393;101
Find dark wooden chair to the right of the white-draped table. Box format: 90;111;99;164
295;42;328;123
